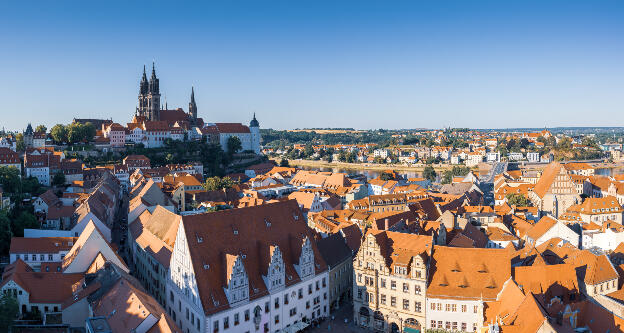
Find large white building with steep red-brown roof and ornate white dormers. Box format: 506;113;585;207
167;201;329;333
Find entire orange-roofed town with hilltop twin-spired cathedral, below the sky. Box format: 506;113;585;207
0;65;624;333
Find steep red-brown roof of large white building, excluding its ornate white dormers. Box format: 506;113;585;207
181;200;327;314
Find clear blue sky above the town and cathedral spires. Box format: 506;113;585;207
0;0;624;129
